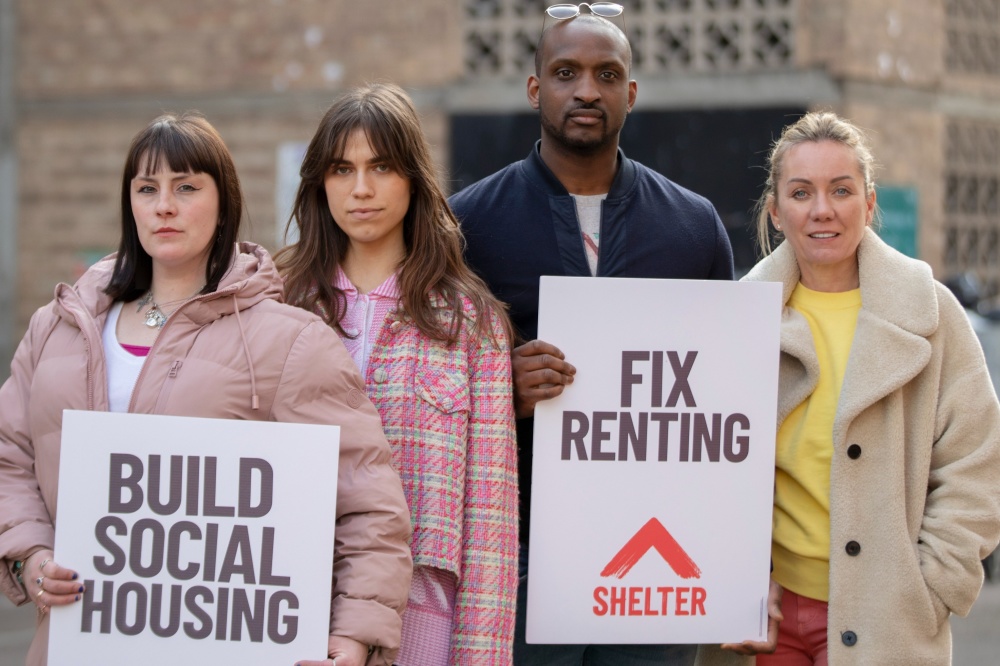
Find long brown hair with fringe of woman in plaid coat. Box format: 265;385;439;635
275;83;511;345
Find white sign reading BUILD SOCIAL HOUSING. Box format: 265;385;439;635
49;411;340;666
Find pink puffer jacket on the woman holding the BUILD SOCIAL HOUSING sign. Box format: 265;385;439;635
0;243;412;666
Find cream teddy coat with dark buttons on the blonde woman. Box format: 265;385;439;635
699;230;1000;666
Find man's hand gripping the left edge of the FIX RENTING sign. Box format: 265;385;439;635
510;340;576;419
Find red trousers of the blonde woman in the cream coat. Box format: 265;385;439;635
757;590;827;666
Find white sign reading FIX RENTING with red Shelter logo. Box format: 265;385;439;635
524;277;781;643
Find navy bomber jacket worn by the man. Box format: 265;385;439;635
449;142;733;543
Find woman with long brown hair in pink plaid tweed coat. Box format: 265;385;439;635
277;84;517;666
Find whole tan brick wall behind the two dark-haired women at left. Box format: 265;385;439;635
16;0;461;338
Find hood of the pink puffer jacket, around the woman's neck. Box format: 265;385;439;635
55;242;283;325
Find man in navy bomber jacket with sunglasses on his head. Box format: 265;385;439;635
450;14;733;665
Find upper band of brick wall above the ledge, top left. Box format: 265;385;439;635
18;0;461;99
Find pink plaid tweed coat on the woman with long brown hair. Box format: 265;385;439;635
356;298;518;665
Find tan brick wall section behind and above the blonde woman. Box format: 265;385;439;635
799;0;956;277
